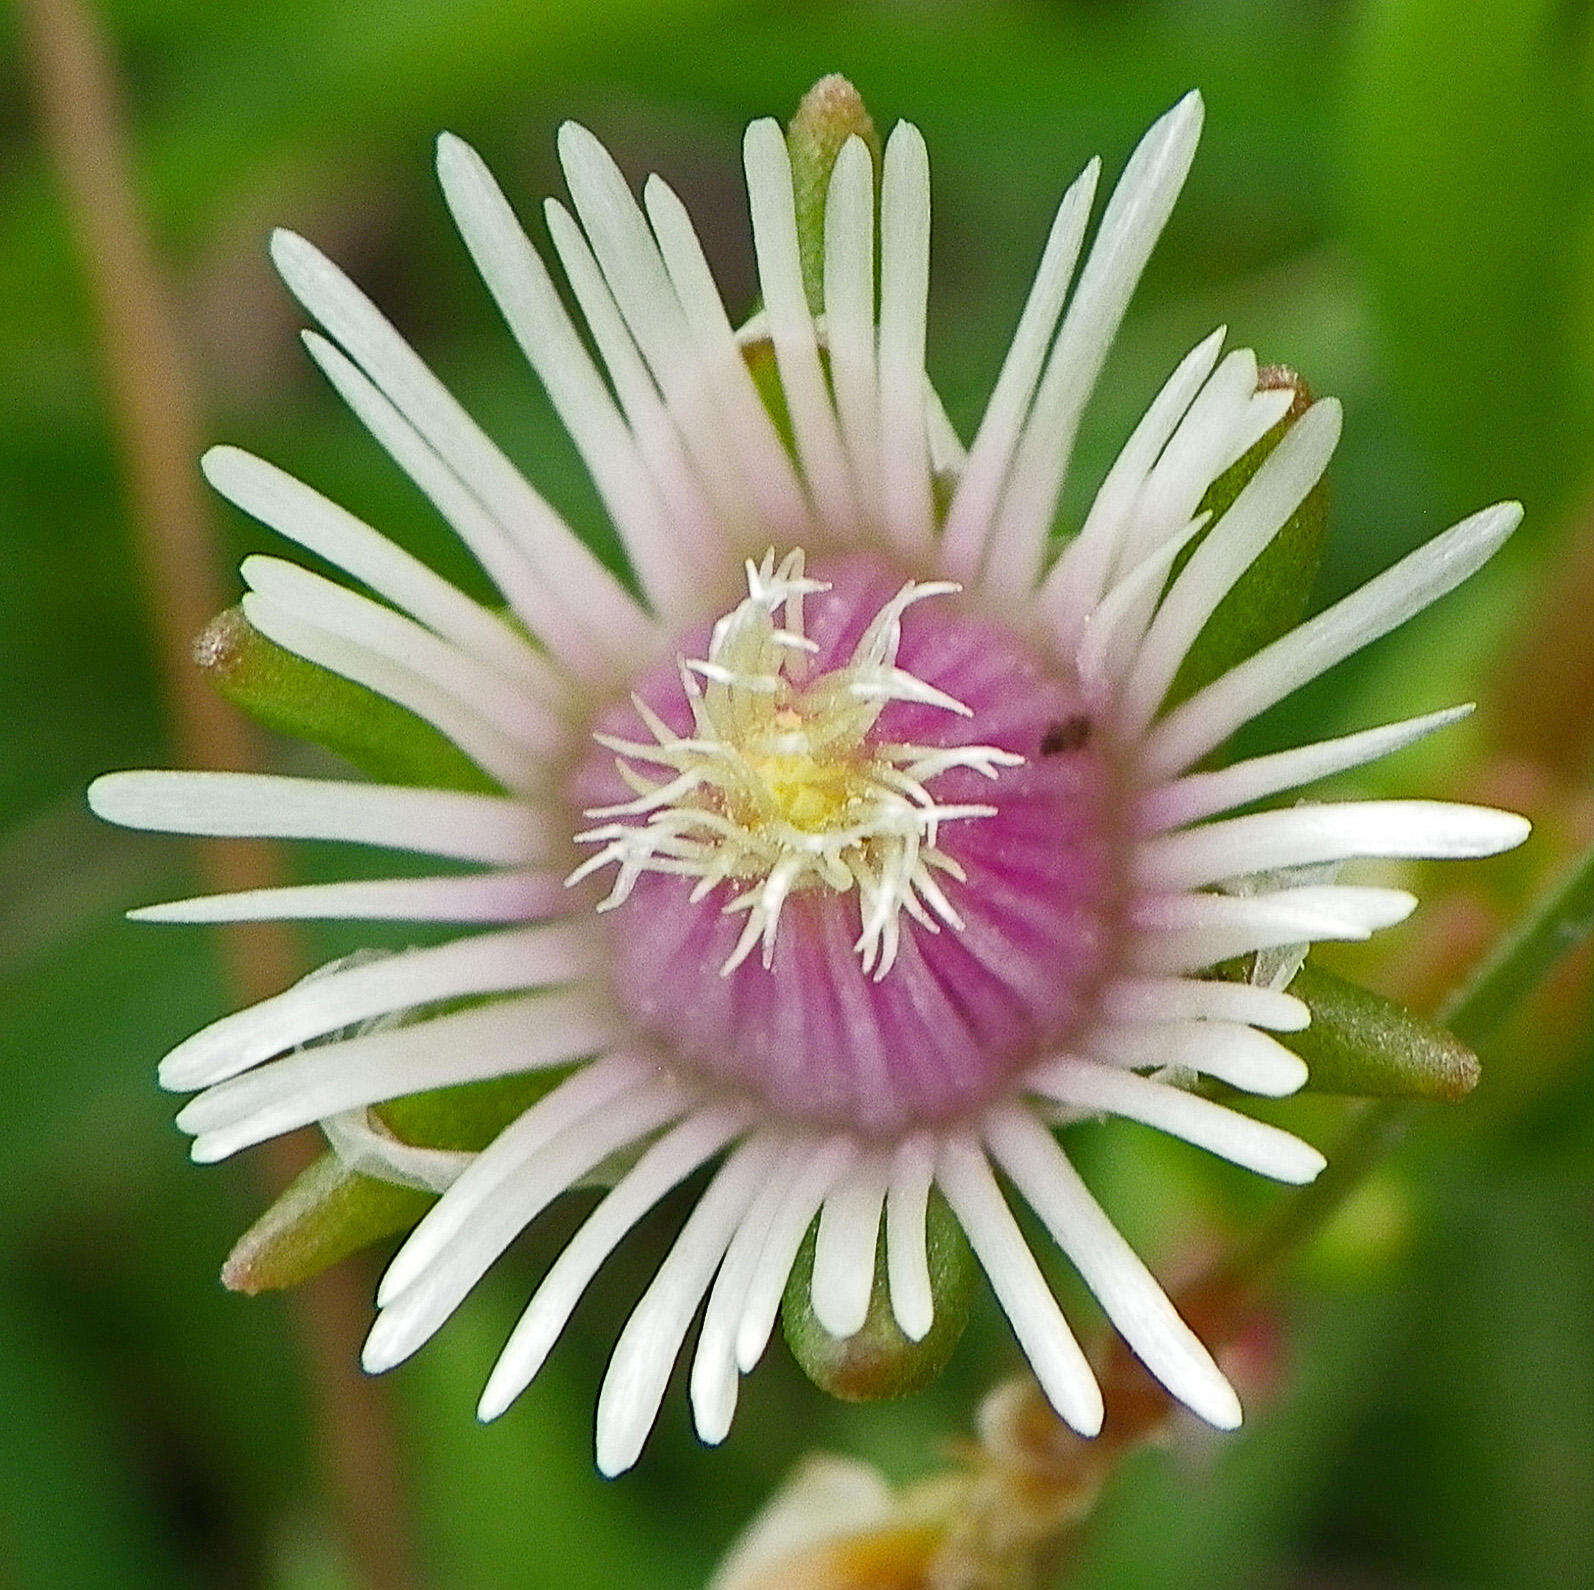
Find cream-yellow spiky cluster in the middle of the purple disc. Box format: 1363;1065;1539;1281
566;549;1023;981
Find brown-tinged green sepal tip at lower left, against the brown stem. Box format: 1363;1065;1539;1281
222;1153;435;1292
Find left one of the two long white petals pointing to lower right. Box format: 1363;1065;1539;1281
936;1137;1105;1435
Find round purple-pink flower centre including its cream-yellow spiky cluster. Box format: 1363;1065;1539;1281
571;553;1122;1134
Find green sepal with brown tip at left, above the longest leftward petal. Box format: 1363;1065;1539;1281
194;608;501;794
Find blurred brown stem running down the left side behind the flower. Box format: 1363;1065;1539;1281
19;0;416;1590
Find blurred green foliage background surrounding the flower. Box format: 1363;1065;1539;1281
0;0;1594;1590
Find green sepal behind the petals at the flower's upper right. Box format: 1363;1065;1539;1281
1165;365;1328;708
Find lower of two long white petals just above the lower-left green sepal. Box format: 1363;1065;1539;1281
177;990;615;1163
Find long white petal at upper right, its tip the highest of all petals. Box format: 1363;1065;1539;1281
985;94;1202;596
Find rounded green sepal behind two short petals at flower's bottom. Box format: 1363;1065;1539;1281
781;1191;977;1402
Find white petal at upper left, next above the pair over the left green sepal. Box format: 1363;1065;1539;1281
199;446;563;702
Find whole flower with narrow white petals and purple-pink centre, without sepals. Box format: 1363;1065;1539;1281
91;94;1527;1474
